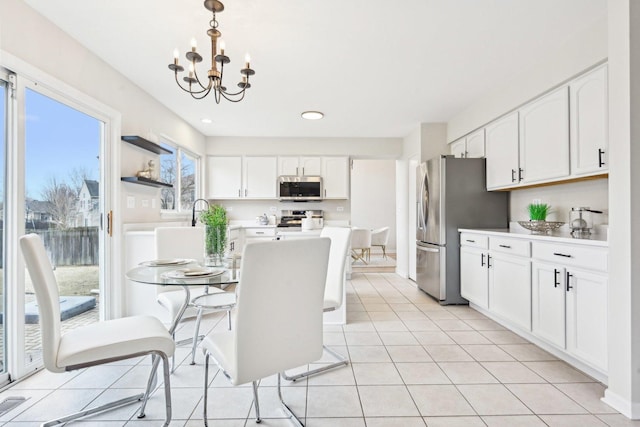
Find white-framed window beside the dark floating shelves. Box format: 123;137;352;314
160;143;198;212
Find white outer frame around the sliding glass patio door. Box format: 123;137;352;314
0;52;123;379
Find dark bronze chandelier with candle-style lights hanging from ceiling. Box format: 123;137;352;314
169;0;255;104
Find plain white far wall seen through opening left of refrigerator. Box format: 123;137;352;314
351;159;396;253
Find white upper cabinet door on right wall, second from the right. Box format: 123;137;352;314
519;86;570;184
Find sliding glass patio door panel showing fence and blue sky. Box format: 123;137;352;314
12;75;114;378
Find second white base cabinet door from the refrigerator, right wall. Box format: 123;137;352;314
489;252;531;331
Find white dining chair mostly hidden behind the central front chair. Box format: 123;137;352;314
282;227;351;381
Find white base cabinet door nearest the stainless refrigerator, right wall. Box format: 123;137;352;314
460;246;489;309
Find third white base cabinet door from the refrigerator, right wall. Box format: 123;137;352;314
531;262;565;348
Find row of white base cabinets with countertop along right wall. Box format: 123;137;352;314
458;227;609;383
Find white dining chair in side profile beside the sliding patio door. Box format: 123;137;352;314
20;234;175;427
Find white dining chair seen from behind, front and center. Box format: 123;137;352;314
202;238;331;426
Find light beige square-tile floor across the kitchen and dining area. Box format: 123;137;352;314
0;273;640;427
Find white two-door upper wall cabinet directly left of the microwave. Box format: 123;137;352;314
207;156;277;199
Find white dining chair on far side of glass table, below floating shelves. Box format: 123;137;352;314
155;227;231;371
